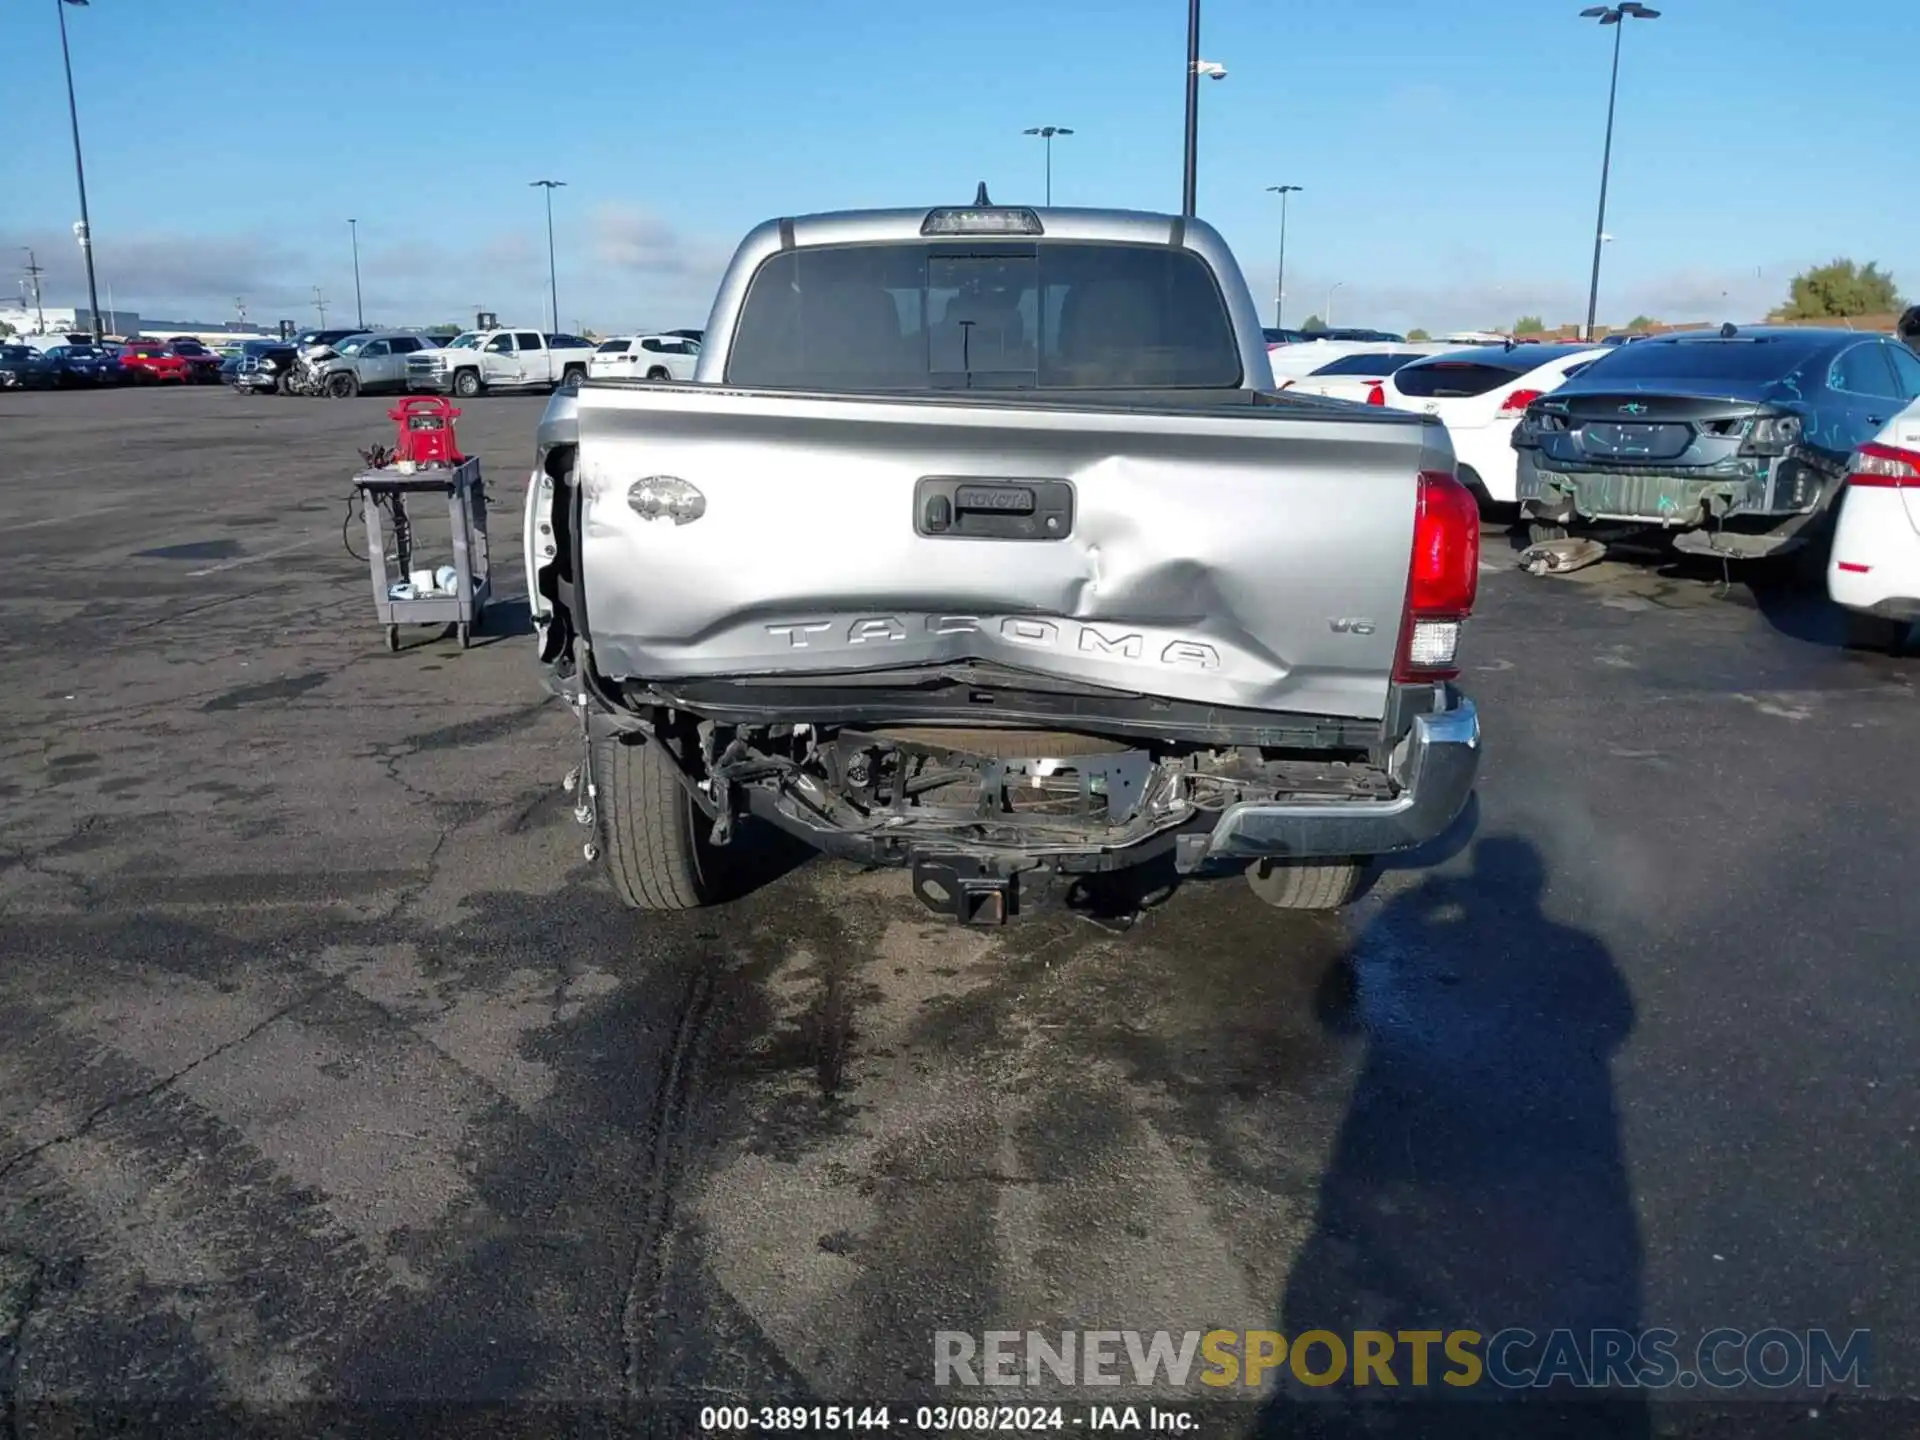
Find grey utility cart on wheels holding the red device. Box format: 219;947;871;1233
353;459;493;651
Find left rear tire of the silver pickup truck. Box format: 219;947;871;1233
593;737;720;910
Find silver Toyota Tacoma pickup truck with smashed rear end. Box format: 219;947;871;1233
524;186;1480;924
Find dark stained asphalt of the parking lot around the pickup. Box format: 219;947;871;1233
0;390;1920;1434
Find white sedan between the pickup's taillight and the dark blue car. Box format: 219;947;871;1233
1382;346;1613;505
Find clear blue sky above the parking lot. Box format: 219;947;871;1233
0;0;1920;332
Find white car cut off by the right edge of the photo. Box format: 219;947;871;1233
1826;401;1920;651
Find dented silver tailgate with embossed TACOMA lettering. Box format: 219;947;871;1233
560;386;1452;718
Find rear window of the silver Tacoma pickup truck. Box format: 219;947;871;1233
728;240;1240;390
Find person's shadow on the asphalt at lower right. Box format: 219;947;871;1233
1258;837;1647;1440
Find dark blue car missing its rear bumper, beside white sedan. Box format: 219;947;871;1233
1513;324;1920;559
